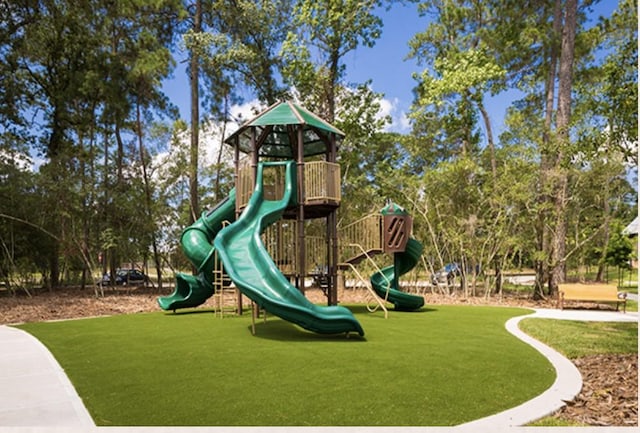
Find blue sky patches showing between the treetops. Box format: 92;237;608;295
164;0;618;135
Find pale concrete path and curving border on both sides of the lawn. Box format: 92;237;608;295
0;309;638;431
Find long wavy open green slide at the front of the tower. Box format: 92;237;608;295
213;161;364;335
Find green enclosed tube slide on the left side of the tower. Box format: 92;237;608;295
158;189;236;311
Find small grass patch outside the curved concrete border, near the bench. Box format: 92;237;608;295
520;319;638;359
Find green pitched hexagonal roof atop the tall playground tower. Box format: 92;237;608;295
225;102;344;158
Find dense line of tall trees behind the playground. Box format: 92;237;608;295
0;0;637;296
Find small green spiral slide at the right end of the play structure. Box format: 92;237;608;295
371;238;424;311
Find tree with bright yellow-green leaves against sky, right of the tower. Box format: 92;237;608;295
410;0;506;177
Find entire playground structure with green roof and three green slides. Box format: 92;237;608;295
158;102;424;335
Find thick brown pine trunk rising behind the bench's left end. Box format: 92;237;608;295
549;0;578;295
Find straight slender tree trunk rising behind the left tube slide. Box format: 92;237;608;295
189;0;202;224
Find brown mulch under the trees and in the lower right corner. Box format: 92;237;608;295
0;287;638;426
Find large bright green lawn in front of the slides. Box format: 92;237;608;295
19;306;555;426
